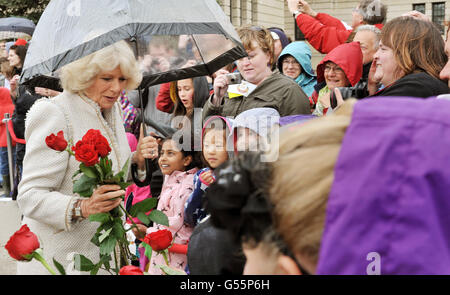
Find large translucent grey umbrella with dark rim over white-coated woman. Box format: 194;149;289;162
21;0;247;90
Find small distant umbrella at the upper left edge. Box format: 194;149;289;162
0;17;36;40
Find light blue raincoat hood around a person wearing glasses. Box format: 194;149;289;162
277;41;317;97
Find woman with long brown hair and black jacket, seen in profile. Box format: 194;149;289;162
368;16;449;98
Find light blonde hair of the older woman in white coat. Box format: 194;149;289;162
60;41;142;93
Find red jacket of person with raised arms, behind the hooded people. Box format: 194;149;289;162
296;13;383;53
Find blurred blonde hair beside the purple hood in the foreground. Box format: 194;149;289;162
269;99;356;264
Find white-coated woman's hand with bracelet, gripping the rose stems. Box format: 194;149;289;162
81;184;125;218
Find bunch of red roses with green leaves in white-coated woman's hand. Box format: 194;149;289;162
45;129;169;274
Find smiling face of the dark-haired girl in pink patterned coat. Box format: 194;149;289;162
158;140;192;175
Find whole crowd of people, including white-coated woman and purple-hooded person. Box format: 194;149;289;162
0;0;450;275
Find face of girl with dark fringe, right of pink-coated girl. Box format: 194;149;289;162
203;129;228;169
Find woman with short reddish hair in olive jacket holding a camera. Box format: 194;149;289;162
203;26;311;119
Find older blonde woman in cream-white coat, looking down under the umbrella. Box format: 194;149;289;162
17;41;157;274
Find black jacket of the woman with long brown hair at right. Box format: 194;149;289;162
373;72;450;98
